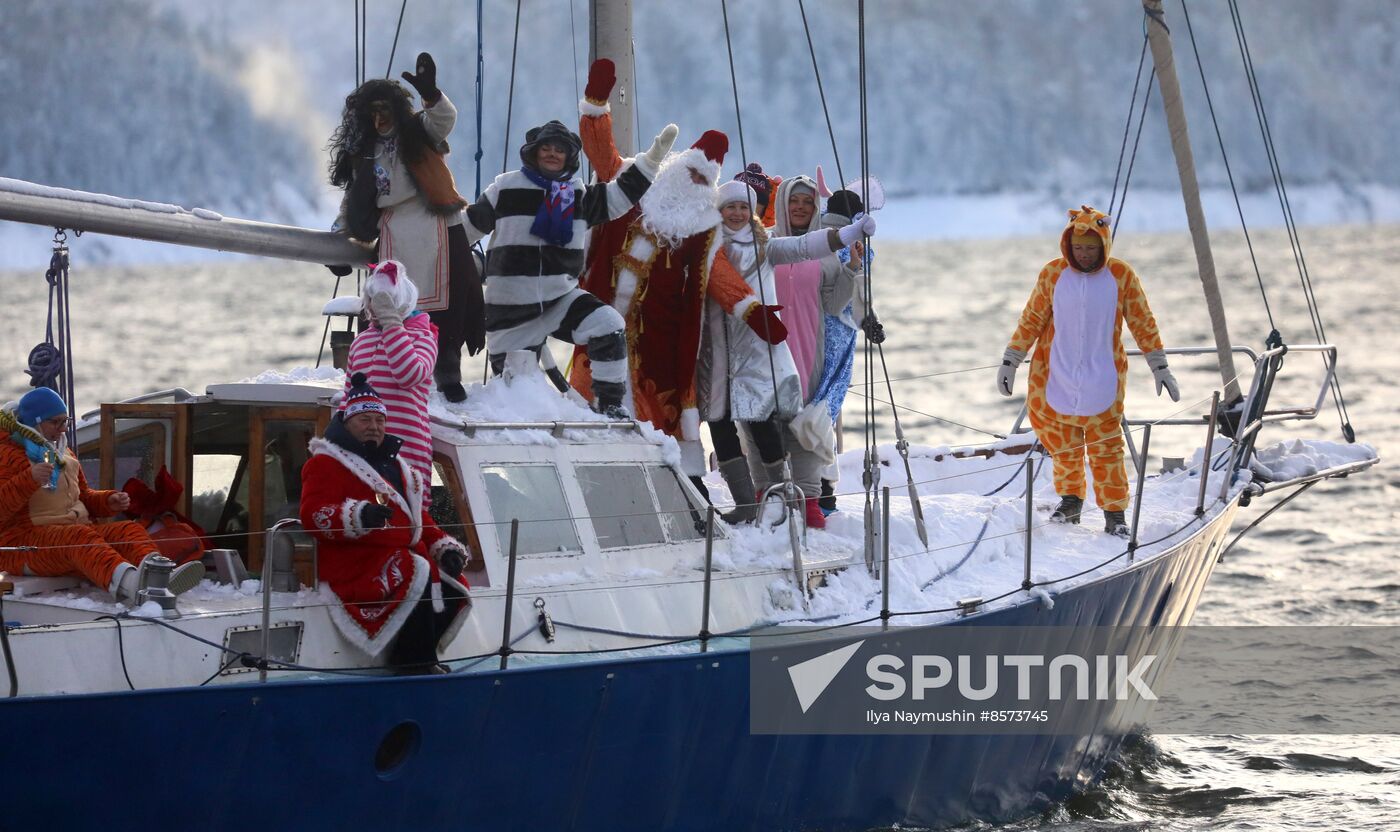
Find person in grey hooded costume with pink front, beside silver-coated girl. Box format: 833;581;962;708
745;175;875;528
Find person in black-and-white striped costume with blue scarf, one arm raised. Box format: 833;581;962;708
466;112;678;419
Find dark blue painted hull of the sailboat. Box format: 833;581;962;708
0;501;1233;832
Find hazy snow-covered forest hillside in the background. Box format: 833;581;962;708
0;0;1400;261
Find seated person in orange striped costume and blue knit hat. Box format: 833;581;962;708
0;387;204;605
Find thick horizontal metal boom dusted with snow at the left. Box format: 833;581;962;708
0;179;374;265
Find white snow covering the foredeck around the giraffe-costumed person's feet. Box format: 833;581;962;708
707;438;1376;625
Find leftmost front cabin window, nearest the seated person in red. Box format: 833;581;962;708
482;465;582;555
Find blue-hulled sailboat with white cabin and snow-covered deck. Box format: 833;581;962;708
0;0;1376;831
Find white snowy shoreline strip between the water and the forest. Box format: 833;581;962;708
0;185;1400;270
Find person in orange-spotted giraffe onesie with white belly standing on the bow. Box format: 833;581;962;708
997;206;1180;536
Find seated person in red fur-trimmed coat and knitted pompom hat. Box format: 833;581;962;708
301;373;470;672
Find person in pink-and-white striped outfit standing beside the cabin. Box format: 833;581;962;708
346;261;437;500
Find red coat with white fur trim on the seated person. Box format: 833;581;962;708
301;438;470;656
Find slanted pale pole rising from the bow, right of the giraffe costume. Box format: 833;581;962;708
1142;0;1243;406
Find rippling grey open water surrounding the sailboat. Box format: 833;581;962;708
0;218;1400;832
